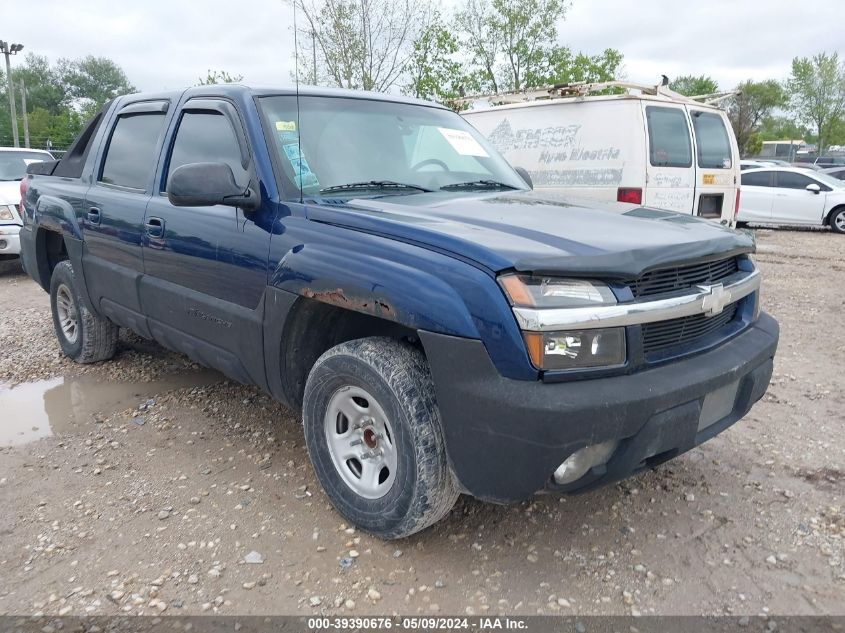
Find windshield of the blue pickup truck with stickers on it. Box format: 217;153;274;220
260;96;526;198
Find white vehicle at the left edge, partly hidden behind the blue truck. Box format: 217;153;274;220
0;147;53;260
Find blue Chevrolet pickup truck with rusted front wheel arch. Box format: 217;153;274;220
20;86;778;538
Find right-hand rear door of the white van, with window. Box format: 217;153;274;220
687;106;739;222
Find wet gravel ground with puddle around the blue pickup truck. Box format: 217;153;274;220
0;230;845;615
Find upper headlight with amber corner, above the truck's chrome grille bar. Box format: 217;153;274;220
499;275;616;308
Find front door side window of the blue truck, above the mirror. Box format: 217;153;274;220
165;110;249;189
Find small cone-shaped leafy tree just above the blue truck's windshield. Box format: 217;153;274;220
404;10;477;110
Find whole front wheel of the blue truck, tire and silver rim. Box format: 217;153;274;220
302;338;459;539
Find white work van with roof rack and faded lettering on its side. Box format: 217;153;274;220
463;82;740;225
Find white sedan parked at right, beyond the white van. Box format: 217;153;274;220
737;167;845;233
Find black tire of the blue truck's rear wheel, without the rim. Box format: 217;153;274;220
50;260;119;363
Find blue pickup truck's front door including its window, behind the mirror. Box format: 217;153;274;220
141;99;272;384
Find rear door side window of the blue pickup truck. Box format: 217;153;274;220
100;112;164;191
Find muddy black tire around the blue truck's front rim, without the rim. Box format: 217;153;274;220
302;338;459;539
